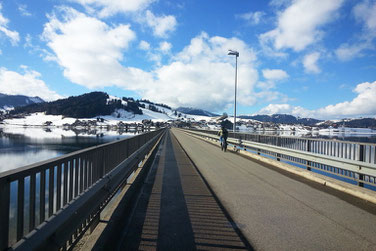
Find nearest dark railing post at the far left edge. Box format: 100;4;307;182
0;179;10;250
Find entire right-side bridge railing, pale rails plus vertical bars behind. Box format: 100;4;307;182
185;129;376;189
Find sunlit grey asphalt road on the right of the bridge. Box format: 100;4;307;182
172;129;376;250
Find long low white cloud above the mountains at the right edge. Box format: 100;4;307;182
258;81;376;119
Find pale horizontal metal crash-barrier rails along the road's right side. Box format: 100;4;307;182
184;129;376;188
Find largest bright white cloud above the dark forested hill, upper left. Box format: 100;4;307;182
42;8;143;88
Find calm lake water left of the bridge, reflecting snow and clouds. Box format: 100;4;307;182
0;127;142;175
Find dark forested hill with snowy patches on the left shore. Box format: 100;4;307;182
10;92;142;118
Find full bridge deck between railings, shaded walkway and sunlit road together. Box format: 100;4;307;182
91;129;376;250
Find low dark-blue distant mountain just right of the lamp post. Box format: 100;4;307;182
239;114;322;125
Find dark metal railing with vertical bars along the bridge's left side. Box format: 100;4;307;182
0;129;164;250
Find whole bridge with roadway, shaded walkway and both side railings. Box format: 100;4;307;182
0;128;376;250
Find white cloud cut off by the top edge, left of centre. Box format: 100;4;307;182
69;0;155;17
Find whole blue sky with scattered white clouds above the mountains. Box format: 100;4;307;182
0;0;376;119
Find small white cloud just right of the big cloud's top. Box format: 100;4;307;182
145;10;177;37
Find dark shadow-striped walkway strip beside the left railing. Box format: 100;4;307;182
114;132;251;250
